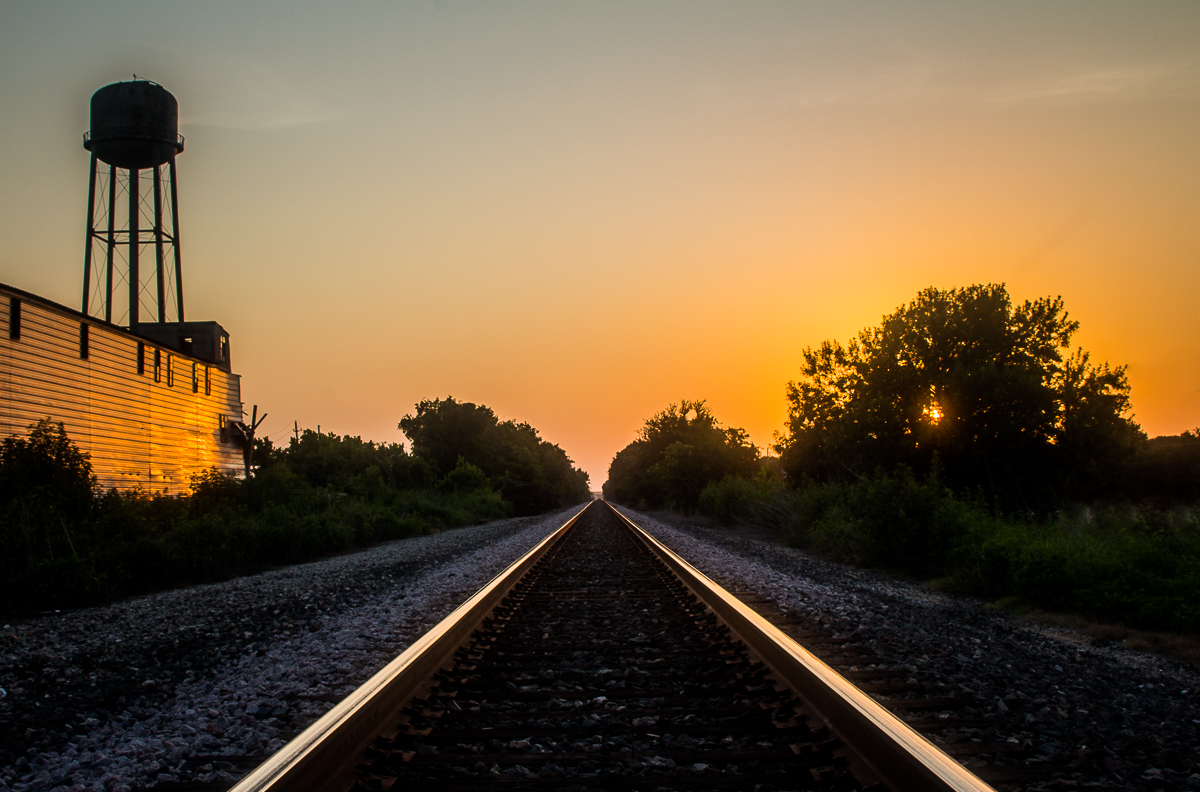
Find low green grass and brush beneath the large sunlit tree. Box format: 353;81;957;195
700;468;1200;632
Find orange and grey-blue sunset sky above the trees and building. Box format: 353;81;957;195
0;0;1200;488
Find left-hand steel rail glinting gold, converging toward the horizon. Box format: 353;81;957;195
230;504;592;792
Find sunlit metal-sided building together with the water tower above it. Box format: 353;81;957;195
0;79;248;494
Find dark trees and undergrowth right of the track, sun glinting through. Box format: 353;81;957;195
605;286;1200;631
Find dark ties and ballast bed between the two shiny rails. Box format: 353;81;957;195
350;504;863;792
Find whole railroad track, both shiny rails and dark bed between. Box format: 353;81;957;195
225;503;990;792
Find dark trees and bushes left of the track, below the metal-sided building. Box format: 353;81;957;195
0;398;590;613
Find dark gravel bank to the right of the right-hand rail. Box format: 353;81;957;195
622;509;1200;792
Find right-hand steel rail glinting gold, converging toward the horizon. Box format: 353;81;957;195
605;502;994;792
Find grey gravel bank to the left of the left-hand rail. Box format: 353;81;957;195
0;506;578;792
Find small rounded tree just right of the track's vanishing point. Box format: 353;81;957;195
604;400;758;511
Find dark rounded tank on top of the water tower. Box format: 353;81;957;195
83;80;184;170
